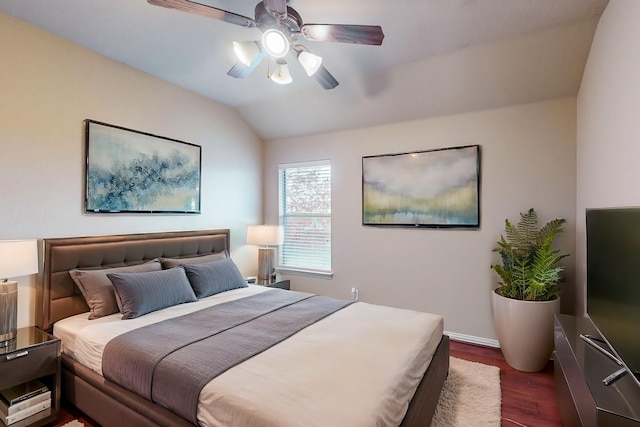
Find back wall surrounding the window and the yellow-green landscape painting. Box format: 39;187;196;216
264;98;576;342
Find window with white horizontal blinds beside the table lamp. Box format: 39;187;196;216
278;160;331;277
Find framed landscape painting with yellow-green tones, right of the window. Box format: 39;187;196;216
362;145;480;229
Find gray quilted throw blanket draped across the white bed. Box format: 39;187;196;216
102;289;351;424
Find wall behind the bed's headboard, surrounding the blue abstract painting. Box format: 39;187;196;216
0;14;262;327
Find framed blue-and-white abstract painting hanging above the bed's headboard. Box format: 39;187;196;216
84;119;202;214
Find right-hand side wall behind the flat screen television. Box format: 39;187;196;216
576;0;640;313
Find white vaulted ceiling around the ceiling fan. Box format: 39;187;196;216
0;0;607;140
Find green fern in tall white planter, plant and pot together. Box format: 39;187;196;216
491;209;568;372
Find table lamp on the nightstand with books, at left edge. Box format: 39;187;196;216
0;240;38;347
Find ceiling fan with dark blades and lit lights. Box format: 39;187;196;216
147;0;384;89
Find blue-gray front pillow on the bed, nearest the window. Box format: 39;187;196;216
182;258;249;298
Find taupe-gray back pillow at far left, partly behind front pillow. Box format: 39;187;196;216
69;259;162;320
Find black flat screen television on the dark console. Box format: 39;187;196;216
586;208;640;387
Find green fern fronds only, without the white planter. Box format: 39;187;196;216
491;208;568;301
